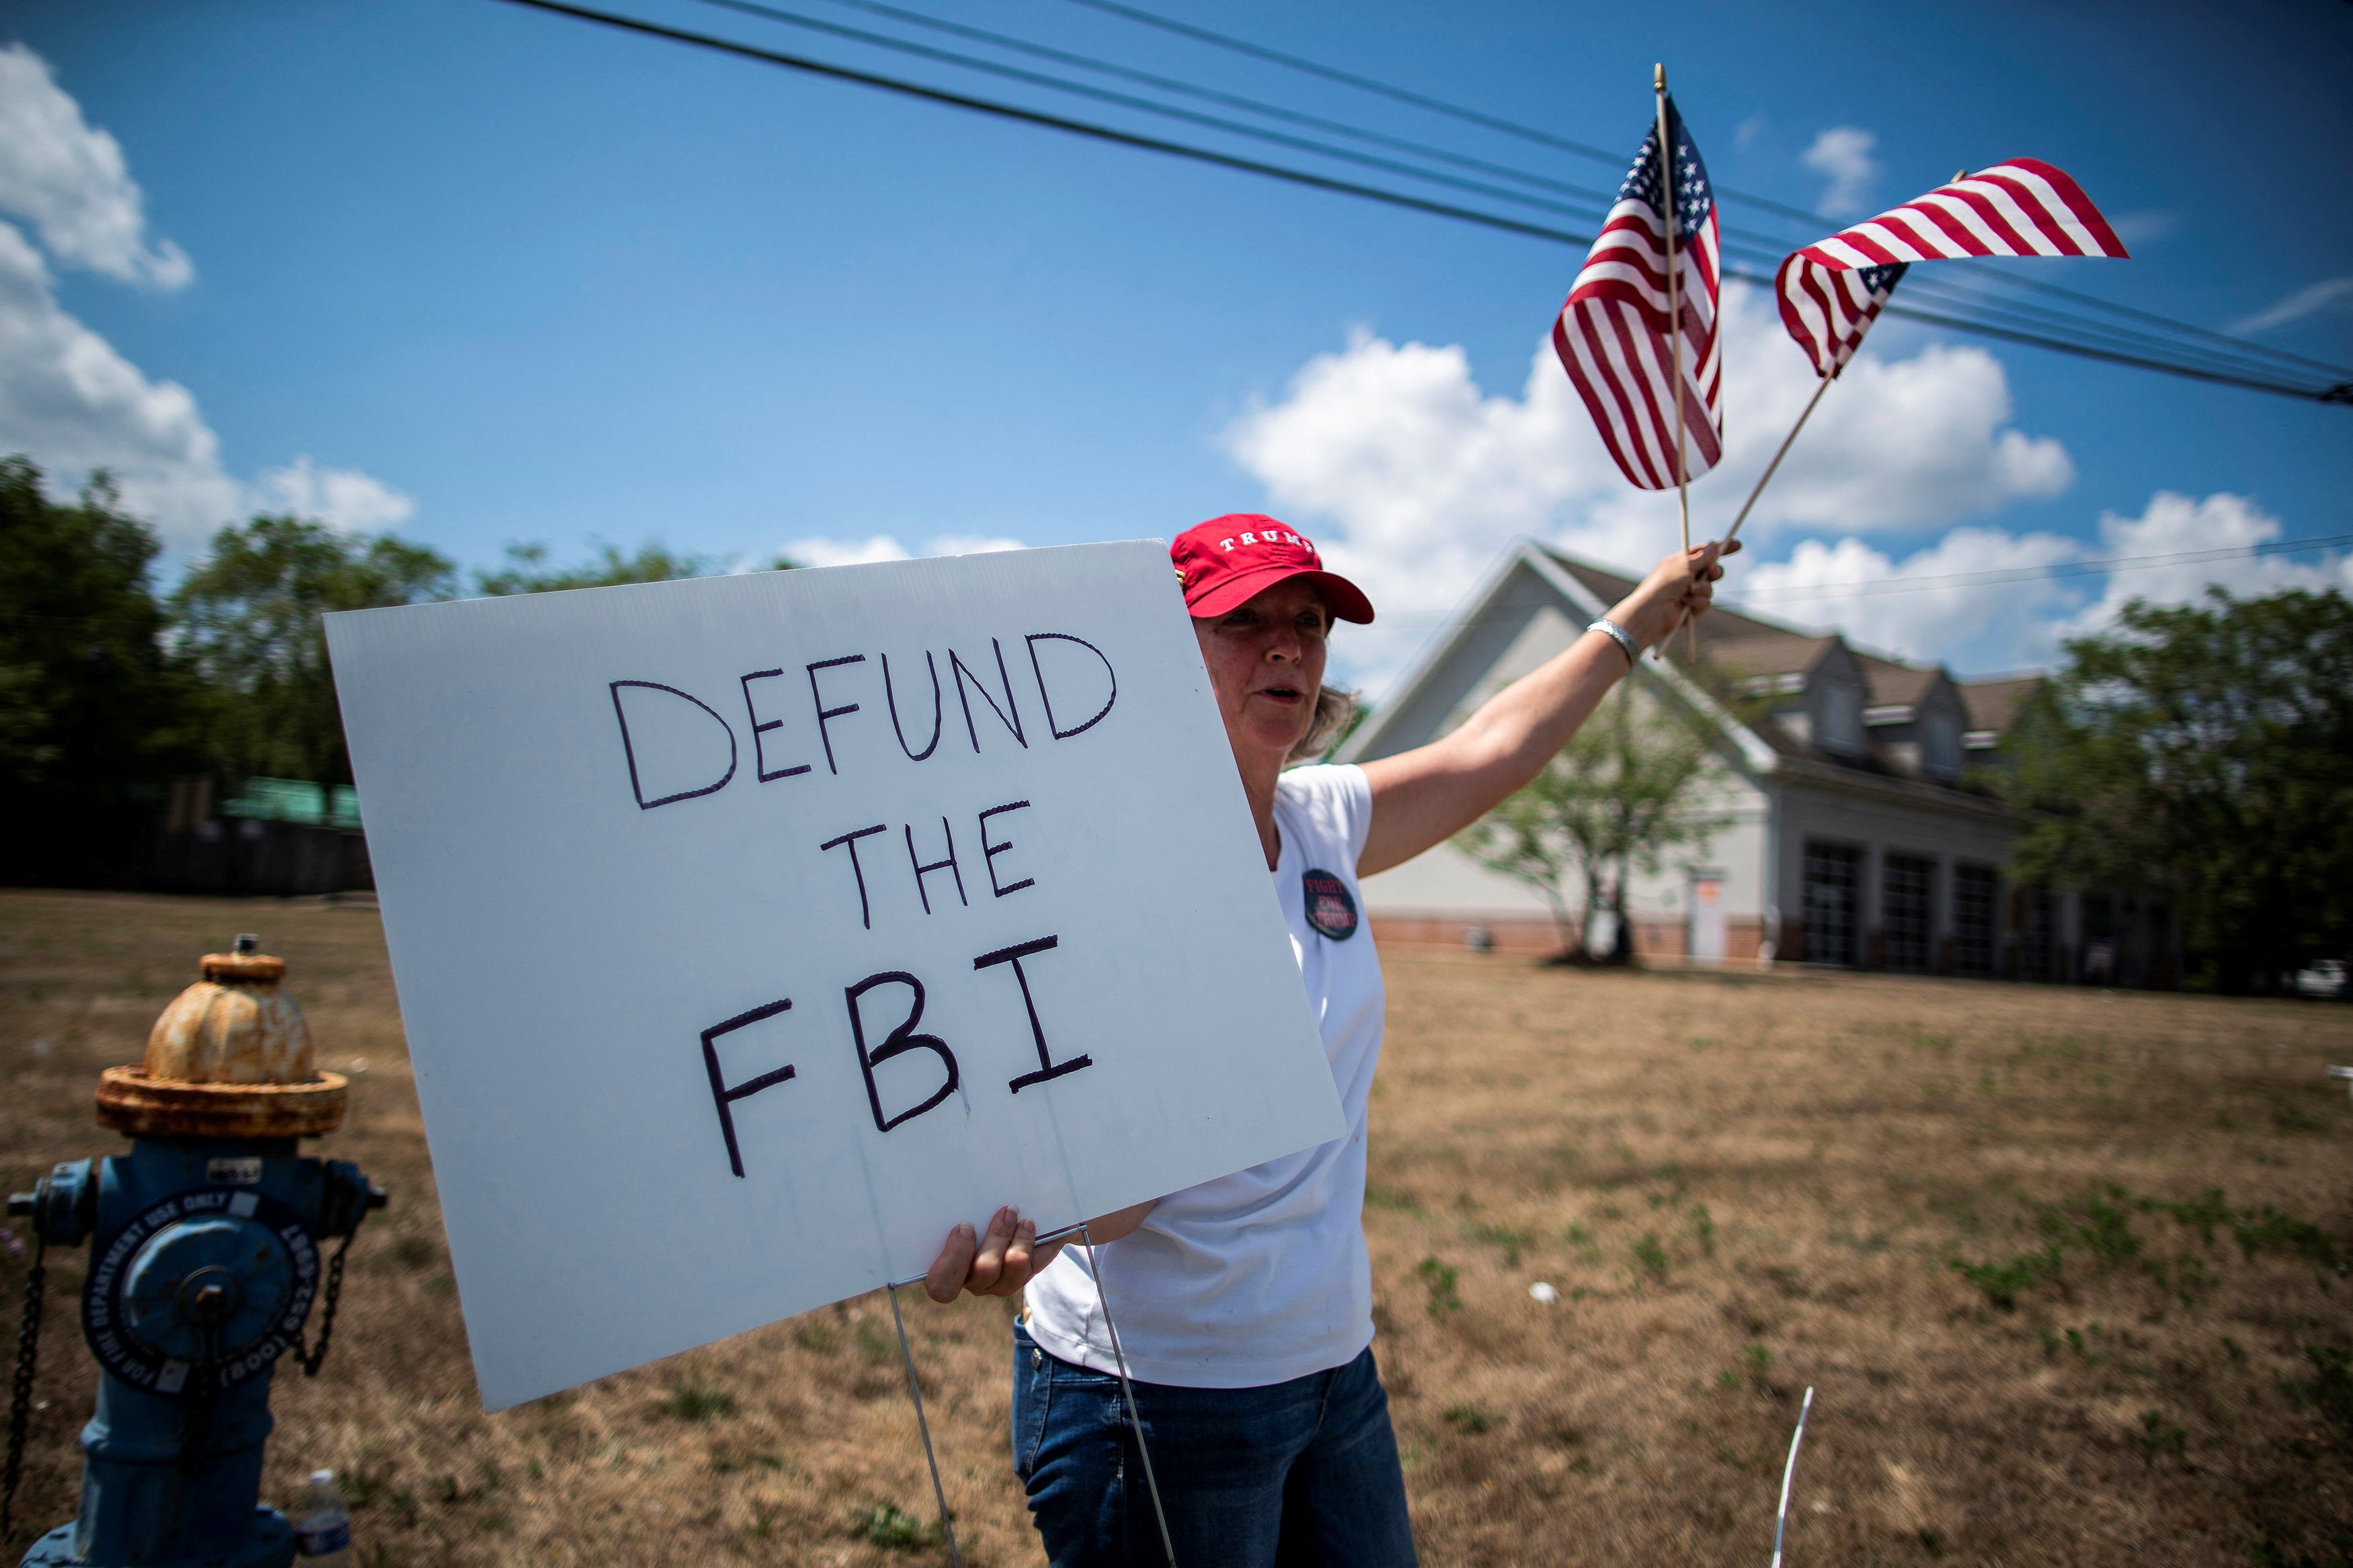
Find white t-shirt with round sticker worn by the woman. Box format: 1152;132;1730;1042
1026;766;1384;1389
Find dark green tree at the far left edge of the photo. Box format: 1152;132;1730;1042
0;456;186;882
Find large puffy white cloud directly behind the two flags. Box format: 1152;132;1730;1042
1224;284;2073;686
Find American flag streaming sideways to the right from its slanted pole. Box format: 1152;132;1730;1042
1774;157;2125;376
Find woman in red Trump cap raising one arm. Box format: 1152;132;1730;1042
925;515;1739;1568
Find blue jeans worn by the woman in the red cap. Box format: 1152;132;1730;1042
1014;1323;1414;1568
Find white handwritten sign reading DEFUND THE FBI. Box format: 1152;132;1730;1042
327;543;1346;1411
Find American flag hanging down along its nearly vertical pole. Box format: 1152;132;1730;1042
1553;99;1725;489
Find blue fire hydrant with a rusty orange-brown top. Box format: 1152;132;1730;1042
7;936;384;1568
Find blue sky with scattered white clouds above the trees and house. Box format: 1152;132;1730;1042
0;0;2353;689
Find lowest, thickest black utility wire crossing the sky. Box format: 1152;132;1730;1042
506;0;2353;405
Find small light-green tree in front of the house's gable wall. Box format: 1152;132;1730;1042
1457;684;1732;957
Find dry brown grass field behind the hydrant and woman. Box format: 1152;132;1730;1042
0;893;2353;1568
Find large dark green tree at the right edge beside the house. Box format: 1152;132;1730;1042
2007;587;2353;992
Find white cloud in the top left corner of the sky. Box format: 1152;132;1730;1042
0;44;196;289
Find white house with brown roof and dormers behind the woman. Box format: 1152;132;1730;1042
1337;543;2174;985
